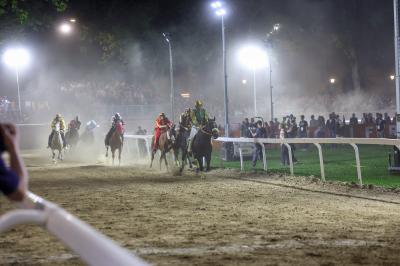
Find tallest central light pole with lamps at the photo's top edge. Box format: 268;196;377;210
211;1;229;137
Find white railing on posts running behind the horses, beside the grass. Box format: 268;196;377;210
127;135;400;185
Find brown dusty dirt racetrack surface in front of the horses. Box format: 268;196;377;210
0;151;400;265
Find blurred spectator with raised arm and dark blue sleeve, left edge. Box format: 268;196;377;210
0;124;28;201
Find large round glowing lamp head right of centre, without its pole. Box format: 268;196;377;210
239;46;268;70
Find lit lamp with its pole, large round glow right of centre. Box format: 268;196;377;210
239;46;268;116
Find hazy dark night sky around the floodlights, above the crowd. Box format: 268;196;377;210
0;0;394;117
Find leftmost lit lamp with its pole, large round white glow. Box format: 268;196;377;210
3;48;31;119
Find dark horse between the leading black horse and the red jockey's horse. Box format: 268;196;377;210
172;125;192;173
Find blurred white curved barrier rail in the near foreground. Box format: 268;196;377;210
0;192;149;266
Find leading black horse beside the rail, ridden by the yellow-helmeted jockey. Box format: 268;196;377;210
192;117;219;171
